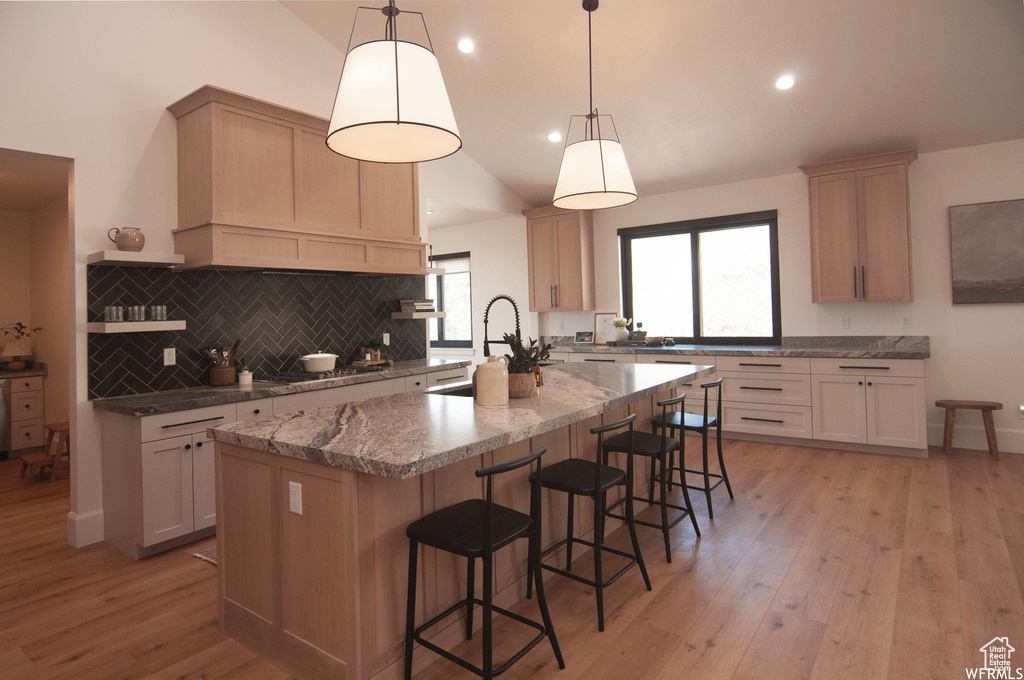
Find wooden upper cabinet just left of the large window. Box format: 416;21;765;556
523;208;594;311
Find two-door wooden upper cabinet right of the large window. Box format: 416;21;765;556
800;150;918;302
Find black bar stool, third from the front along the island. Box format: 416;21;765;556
604;394;700;563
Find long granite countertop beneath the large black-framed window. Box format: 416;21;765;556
547;335;931;359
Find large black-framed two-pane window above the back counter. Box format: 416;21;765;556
618;210;782;344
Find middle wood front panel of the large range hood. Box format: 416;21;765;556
295;128;359;235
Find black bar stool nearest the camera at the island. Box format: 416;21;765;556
406;449;565;680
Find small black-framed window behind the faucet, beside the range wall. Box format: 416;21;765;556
427;253;473;347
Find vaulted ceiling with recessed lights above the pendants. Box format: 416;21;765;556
284;0;1024;206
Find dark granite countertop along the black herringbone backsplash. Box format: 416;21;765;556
90;358;470;416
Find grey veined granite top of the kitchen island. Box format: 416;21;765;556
210;364;713;479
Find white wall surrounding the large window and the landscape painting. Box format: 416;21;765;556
540;139;1024;453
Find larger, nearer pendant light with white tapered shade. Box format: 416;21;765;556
327;0;462;163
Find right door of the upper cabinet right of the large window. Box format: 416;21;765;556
857;165;910;302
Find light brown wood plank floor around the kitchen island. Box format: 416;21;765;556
0;439;1024;680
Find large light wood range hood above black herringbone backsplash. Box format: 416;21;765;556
169;85;426;274
